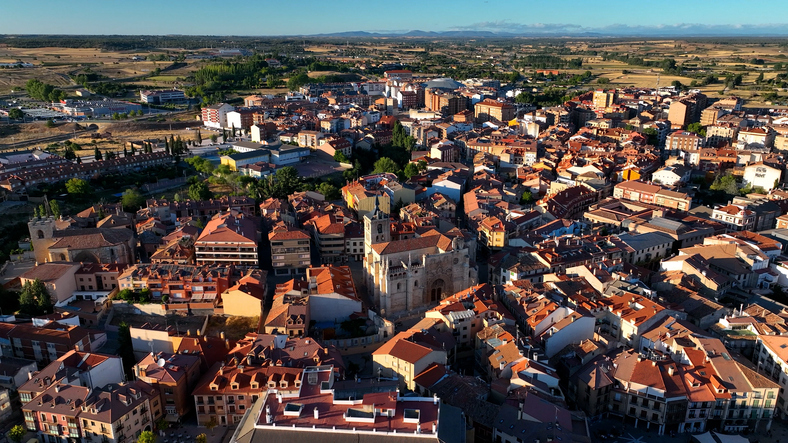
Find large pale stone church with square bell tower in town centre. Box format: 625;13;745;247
364;203;478;317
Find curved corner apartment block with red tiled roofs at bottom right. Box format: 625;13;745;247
570;334;779;435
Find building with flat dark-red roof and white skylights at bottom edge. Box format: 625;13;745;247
230;366;466;443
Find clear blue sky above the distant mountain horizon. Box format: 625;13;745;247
0;0;788;36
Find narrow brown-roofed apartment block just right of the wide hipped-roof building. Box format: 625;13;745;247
268;223;311;275
